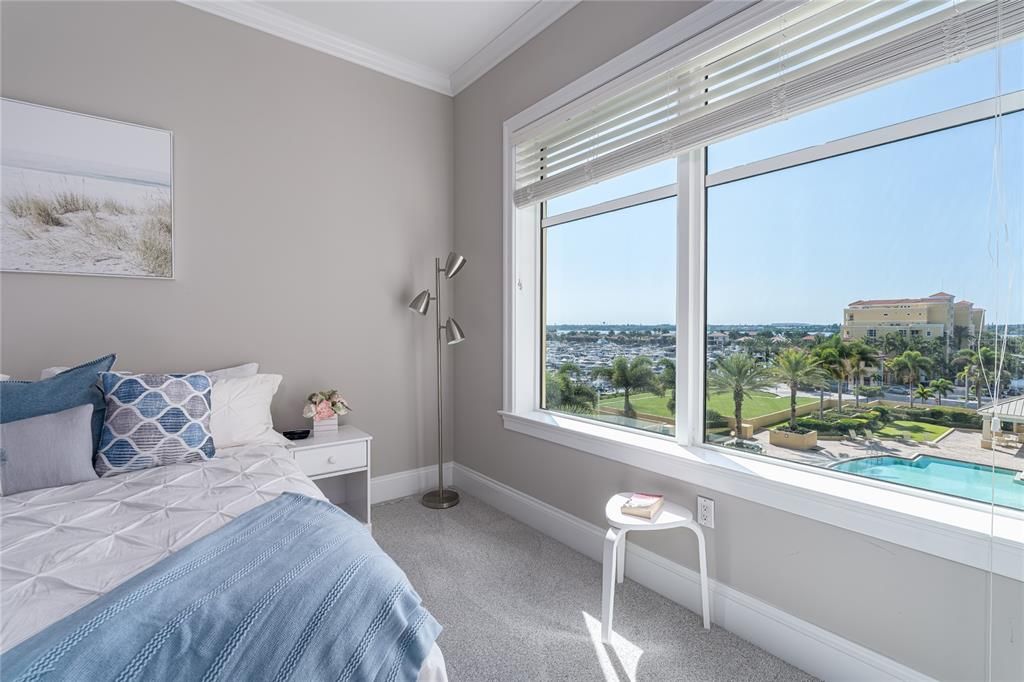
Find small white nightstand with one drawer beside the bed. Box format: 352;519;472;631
289;426;373;526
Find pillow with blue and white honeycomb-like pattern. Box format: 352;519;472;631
96;372;215;476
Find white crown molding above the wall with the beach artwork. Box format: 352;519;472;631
178;0;453;96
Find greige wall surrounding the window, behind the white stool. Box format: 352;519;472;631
455;2;1024;680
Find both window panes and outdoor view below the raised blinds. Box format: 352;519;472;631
538;25;1024;503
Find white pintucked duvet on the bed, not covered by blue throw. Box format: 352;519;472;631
0;445;447;682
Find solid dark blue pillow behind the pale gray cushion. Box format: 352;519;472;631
0;354;117;452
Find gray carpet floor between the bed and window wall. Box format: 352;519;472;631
373;496;813;682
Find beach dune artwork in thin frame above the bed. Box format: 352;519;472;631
0;98;174;279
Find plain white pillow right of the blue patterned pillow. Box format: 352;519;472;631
210;374;289;449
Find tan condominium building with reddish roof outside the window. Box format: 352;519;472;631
843;291;985;347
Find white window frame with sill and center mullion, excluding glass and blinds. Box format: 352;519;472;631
499;2;1024;582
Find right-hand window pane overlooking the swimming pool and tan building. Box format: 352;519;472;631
703;42;1024;510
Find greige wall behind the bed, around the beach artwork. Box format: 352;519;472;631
0;2;456;474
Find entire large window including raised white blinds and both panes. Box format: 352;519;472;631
520;0;1024;514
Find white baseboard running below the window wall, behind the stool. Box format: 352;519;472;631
452;463;931;682
